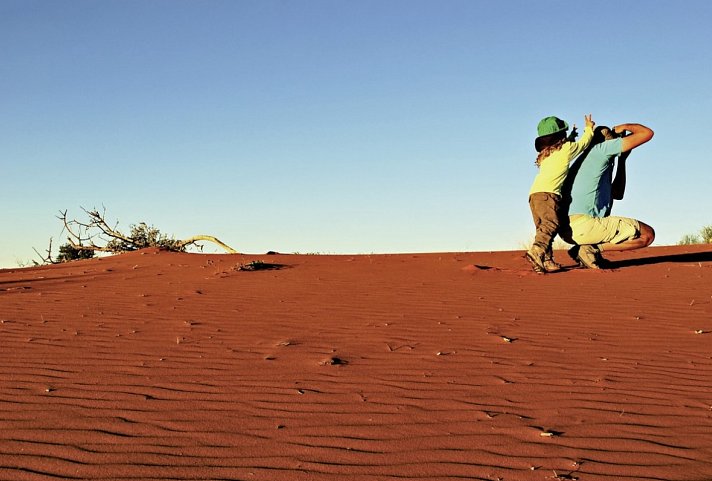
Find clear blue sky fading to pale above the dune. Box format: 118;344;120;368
0;0;712;267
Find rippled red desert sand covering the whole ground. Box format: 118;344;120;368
0;246;712;481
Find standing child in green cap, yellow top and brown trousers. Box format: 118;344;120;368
524;114;595;274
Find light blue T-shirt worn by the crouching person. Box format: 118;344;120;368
563;138;622;217
